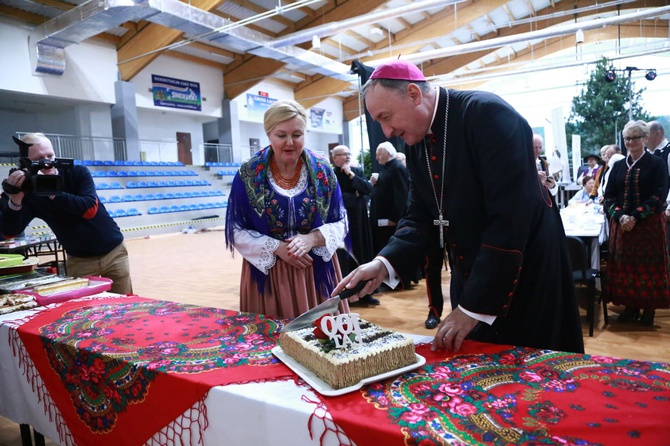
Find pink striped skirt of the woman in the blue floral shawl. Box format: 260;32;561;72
240;255;349;319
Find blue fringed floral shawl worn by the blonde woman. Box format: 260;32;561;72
226;146;351;298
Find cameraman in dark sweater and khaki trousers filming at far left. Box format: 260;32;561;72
0;133;132;294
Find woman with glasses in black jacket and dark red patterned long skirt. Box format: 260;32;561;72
603;121;670;326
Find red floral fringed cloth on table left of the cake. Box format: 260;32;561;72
15;296;294;445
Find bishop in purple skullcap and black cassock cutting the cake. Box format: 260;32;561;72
333;60;584;352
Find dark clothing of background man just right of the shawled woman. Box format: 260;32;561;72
333;166;374;276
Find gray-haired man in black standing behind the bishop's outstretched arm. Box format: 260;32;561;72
370;141;409;253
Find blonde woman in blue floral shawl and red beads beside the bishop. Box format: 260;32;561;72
226;101;349;318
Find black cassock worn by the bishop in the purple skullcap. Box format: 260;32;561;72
380;88;584;352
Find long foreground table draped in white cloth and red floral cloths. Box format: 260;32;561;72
0;293;670;446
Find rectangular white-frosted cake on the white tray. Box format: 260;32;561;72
279;319;417;389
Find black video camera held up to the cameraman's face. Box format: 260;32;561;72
2;136;74;196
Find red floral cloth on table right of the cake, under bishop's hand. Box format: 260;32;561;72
322;341;670;446
